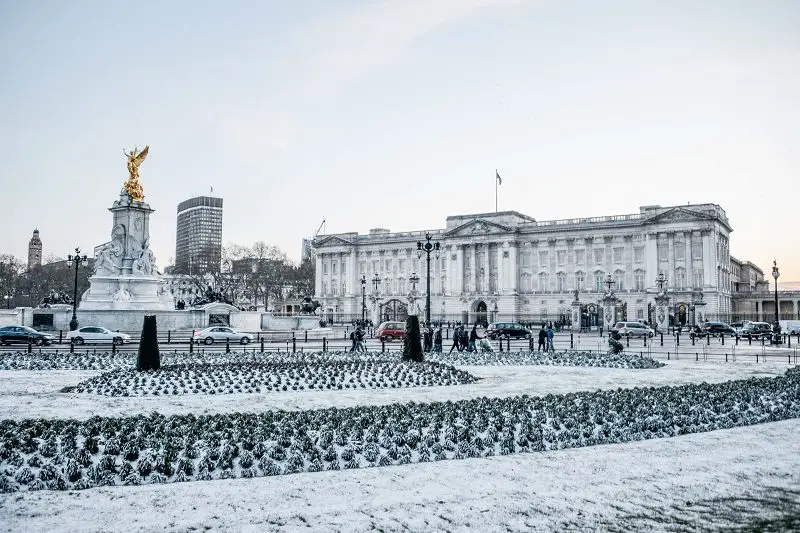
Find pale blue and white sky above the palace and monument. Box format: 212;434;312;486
0;0;800;281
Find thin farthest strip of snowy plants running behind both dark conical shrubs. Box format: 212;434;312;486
0;351;664;370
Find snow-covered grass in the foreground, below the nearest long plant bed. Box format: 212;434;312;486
0;420;800;533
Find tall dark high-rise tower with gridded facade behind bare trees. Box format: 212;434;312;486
174;196;222;274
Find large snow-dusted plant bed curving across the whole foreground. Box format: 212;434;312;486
0;364;800;492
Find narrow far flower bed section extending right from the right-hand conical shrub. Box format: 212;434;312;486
426;351;664;369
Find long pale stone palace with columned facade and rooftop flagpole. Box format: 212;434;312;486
313;204;732;327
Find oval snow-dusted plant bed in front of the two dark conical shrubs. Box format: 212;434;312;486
74;357;476;396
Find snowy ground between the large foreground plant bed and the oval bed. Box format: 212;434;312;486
0;360;790;420
